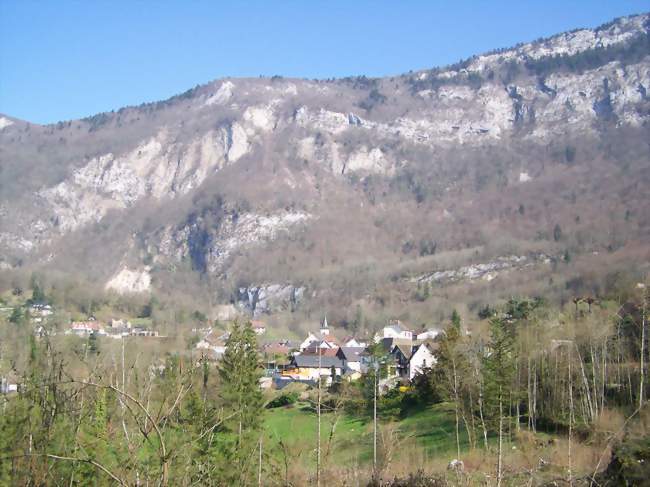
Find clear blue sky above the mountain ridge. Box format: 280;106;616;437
0;0;650;123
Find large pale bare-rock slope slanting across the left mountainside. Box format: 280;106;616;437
38;128;237;233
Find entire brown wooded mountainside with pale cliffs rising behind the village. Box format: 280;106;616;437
0;14;650;325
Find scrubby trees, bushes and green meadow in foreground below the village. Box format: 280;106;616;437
0;276;650;486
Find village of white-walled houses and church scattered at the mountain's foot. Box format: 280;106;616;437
0;294;443;393
